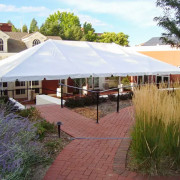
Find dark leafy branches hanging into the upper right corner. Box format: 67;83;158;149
154;0;180;47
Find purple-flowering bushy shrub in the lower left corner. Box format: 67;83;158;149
0;109;49;179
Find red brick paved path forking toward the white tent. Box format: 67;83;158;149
37;105;158;180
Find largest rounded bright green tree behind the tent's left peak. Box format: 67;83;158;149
40;11;83;40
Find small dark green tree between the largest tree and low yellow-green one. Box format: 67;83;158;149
82;22;97;41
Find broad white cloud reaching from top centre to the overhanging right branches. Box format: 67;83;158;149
59;0;160;26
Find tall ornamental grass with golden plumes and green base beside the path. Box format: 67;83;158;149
131;85;180;175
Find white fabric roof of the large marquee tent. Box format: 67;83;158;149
0;40;180;82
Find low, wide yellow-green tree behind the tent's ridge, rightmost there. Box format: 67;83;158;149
99;32;129;46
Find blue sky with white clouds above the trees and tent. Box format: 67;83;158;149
0;0;164;46
